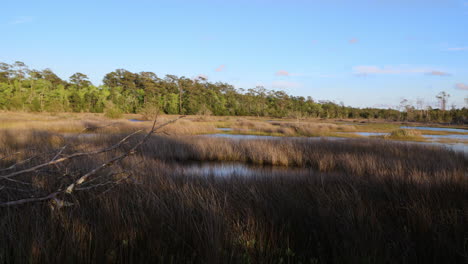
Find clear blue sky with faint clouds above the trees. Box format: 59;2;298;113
0;0;468;108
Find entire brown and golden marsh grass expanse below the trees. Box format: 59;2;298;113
0;112;468;263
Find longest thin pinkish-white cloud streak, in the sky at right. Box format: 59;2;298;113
353;65;450;76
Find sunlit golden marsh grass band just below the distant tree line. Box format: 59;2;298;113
0;112;468;137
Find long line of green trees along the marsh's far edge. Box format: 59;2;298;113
0;61;468;124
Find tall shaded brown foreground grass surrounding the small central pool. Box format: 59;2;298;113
0;131;468;263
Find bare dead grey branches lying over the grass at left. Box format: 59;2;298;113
0;116;184;207
